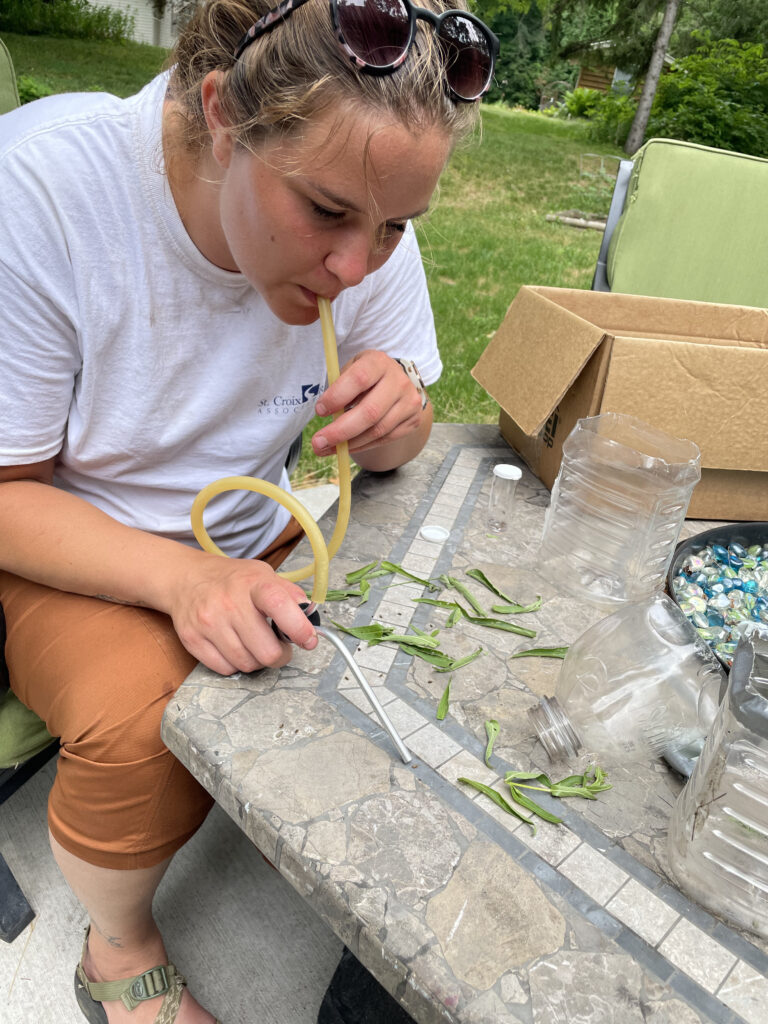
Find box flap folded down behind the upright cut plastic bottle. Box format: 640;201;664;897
601;337;768;472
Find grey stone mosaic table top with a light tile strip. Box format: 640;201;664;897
164;424;768;1024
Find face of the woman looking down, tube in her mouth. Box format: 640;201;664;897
209;96;451;325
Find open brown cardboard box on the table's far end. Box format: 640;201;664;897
472;286;768;520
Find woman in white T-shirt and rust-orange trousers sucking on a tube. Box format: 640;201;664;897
0;0;498;1024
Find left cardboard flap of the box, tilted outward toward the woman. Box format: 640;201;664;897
471;285;610;435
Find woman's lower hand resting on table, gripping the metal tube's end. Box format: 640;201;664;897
166;551;317;676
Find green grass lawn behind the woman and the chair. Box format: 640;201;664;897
3;33;622;481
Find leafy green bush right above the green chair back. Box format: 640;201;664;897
646;39;768;157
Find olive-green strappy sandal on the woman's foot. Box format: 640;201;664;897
75;928;221;1024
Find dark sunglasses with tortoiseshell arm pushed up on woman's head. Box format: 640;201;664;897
234;0;499;102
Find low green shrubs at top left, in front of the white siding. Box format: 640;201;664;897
0;0;134;40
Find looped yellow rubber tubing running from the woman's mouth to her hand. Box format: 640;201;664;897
190;298;352;604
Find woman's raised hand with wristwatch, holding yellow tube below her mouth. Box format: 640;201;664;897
312;349;432;470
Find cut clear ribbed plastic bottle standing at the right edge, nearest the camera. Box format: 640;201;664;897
668;634;768;938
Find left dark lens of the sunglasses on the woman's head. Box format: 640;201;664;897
336;0;411;68
